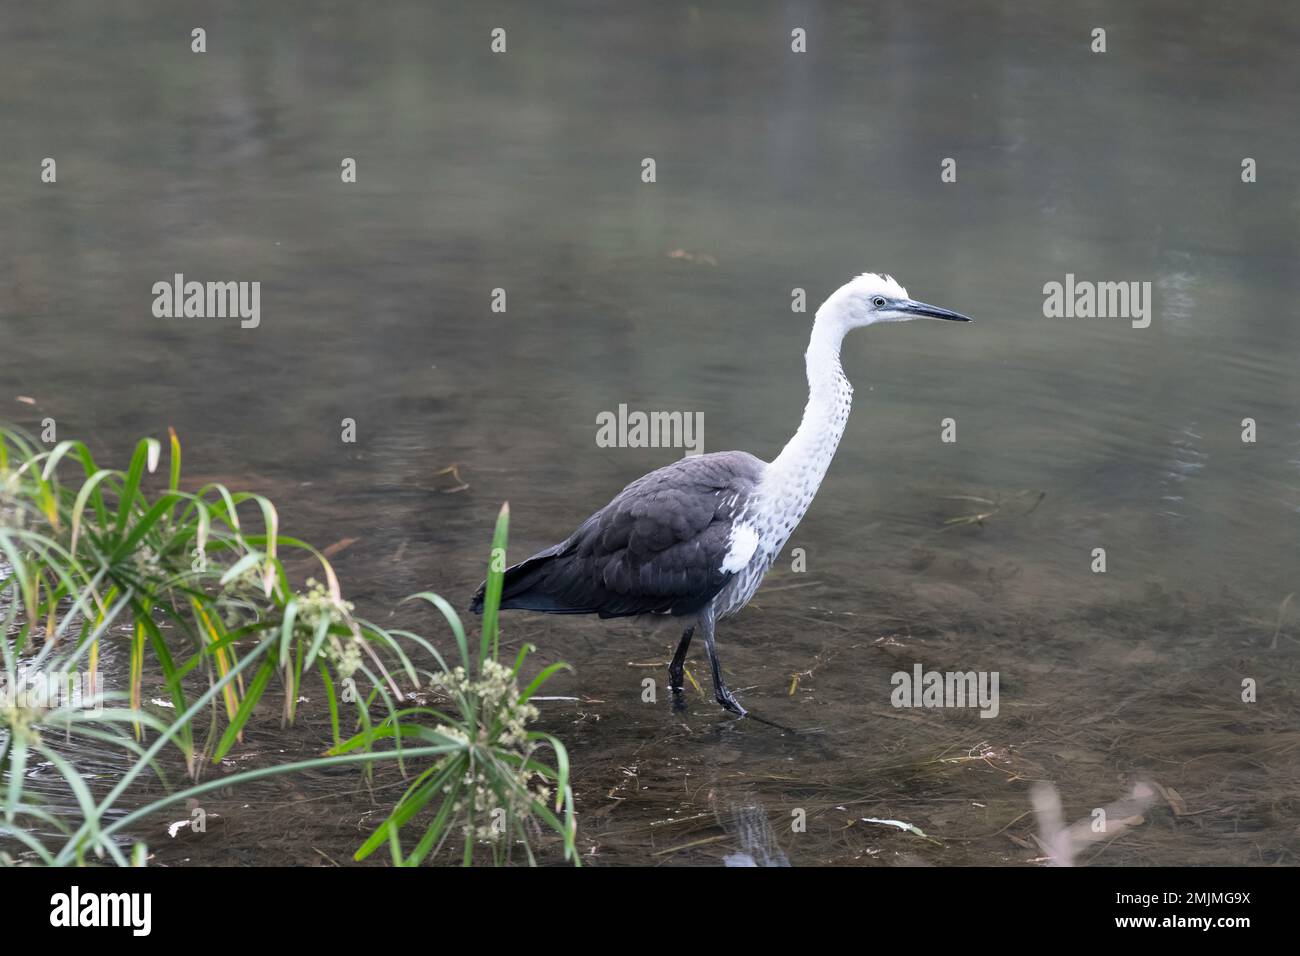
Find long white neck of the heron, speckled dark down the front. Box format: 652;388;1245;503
763;308;853;528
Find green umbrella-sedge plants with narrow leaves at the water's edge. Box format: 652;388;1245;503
0;429;579;865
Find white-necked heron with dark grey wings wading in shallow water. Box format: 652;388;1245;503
471;272;971;717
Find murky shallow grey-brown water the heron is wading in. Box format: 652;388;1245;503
0;3;1300;866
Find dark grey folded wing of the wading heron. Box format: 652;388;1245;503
491;451;763;618
